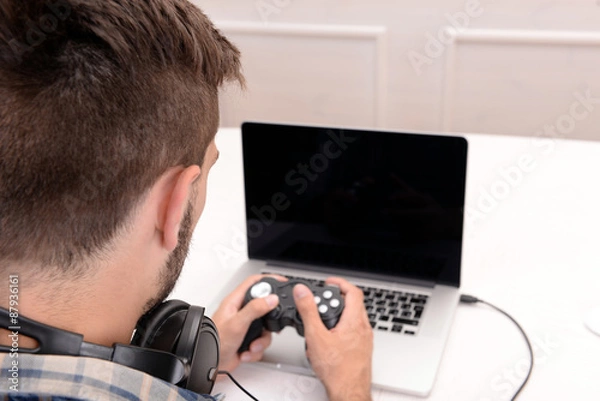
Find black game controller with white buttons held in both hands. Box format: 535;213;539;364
238;277;344;353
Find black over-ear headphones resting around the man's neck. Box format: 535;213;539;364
0;300;220;394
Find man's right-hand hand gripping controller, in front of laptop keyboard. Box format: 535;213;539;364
294;278;373;401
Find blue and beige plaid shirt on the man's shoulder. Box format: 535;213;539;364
0;353;224;401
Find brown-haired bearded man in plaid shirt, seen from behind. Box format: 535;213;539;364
0;0;372;400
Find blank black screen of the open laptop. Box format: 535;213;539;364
242;122;467;287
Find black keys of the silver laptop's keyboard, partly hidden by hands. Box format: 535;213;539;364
265;273;429;336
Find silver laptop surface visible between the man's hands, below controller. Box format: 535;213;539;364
261;327;314;376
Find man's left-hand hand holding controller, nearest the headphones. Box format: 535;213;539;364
211;275;285;371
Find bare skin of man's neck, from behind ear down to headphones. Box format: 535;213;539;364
0;203;170;346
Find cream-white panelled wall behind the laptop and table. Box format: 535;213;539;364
194;0;600;140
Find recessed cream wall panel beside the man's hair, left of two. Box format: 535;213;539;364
218;21;387;126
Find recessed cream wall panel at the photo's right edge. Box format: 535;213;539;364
442;30;600;139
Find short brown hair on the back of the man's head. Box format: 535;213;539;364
0;0;243;271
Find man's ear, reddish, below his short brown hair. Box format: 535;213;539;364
158;165;200;248
